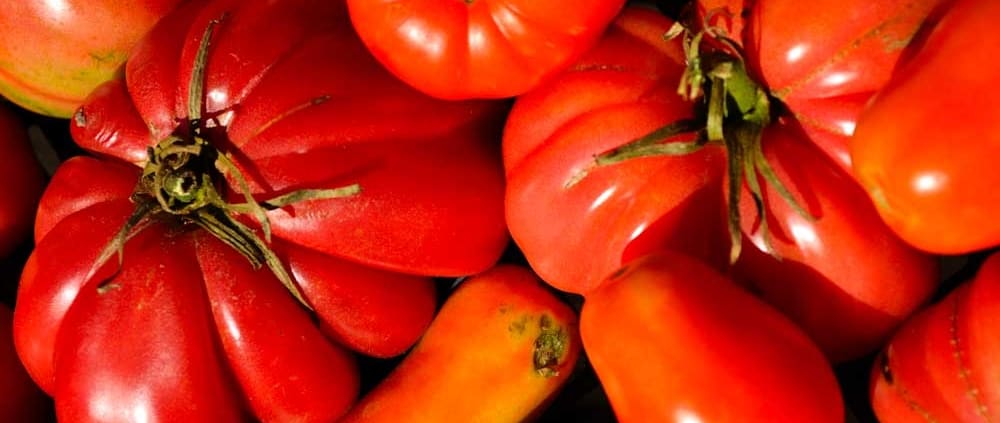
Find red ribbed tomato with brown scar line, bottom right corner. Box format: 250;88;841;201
869;253;1000;423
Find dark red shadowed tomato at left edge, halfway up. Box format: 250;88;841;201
0;102;46;257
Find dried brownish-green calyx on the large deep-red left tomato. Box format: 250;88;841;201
90;14;360;310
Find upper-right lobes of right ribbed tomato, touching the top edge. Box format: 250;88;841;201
696;0;947;174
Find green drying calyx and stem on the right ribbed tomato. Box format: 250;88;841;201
574;19;813;263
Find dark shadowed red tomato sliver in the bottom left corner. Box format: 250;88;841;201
0;303;51;422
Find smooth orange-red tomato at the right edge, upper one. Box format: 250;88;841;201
851;1;1000;254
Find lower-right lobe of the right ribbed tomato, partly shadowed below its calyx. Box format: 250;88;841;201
734;123;939;362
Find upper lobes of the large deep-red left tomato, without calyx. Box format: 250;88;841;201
70;0;509;276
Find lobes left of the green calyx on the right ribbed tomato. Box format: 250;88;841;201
503;7;729;294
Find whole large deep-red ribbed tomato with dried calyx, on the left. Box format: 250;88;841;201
14;0;508;422
